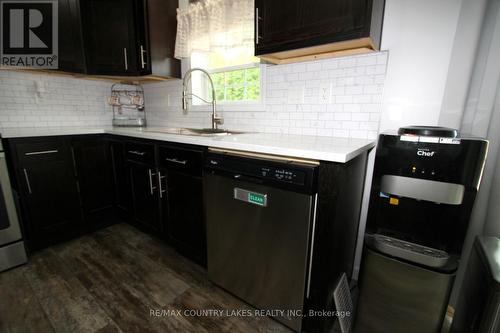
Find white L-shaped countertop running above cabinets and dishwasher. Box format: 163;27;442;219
0;127;375;163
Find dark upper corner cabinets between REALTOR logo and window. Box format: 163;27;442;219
59;0;180;79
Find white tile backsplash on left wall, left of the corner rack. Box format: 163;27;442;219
0;70;113;128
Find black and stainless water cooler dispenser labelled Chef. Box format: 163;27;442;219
355;126;488;333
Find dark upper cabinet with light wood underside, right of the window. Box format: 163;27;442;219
255;0;385;64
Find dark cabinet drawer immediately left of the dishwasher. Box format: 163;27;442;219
159;147;203;176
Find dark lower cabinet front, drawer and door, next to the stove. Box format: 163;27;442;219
14;139;82;248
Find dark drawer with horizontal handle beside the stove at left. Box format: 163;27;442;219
15;138;69;166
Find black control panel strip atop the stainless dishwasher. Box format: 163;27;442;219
205;153;316;192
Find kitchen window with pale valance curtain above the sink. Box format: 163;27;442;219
175;0;265;109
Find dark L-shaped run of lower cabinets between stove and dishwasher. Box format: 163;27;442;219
5;135;206;265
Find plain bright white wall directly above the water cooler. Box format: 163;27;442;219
380;0;462;131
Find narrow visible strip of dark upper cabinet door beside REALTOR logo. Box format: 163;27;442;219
58;0;85;73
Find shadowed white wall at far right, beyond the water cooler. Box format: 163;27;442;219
451;0;500;304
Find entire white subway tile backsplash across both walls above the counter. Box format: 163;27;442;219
0;52;387;139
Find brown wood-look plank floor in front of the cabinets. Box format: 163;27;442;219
0;224;291;333
